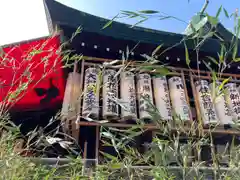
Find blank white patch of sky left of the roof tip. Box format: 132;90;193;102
0;0;49;45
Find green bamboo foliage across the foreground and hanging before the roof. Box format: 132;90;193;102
0;1;240;180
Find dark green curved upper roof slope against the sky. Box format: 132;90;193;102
44;0;240;54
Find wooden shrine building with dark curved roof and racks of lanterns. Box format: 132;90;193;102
3;0;240;173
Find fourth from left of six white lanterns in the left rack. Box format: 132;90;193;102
137;73;153;120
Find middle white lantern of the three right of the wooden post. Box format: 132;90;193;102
209;82;233;124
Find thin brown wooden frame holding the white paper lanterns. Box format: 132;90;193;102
59;57;240;165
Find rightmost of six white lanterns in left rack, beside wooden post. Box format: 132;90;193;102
168;76;190;120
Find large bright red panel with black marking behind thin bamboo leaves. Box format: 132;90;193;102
0;35;65;110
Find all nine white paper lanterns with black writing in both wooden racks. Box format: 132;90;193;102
78;68;240;124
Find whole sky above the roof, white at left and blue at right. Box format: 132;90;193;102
0;0;240;45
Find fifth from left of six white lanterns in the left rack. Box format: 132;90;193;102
153;76;172;120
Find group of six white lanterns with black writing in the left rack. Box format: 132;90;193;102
82;68;190;120
